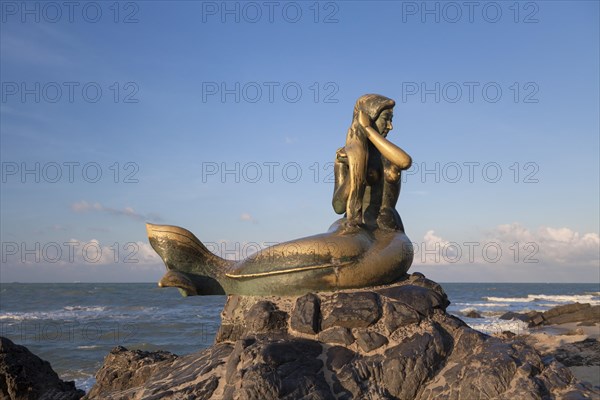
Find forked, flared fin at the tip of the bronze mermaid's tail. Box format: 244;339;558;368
146;224;234;296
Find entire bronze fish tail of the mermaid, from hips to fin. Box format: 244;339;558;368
147;219;413;296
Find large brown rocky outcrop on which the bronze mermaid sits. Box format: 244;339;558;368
87;274;594;400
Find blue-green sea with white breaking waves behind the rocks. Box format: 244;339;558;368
0;283;600;391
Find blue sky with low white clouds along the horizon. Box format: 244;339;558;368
0;1;600;282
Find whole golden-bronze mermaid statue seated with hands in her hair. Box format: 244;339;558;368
146;94;413;296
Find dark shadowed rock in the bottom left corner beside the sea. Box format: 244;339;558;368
0;337;85;400
